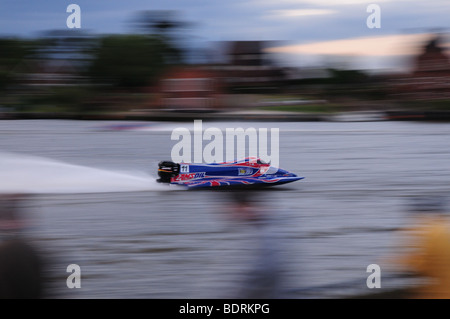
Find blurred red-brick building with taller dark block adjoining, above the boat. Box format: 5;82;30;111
151;41;286;110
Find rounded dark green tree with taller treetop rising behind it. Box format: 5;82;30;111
87;11;187;88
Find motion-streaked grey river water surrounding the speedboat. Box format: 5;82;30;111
0;120;450;298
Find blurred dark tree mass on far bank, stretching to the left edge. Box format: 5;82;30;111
0;11;188;113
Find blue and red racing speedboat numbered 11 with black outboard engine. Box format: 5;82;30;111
157;157;304;188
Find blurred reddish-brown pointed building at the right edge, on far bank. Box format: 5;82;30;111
391;35;450;100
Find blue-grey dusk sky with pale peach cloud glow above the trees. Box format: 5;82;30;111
0;0;450;69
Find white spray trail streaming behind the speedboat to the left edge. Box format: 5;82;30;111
0;153;173;194
